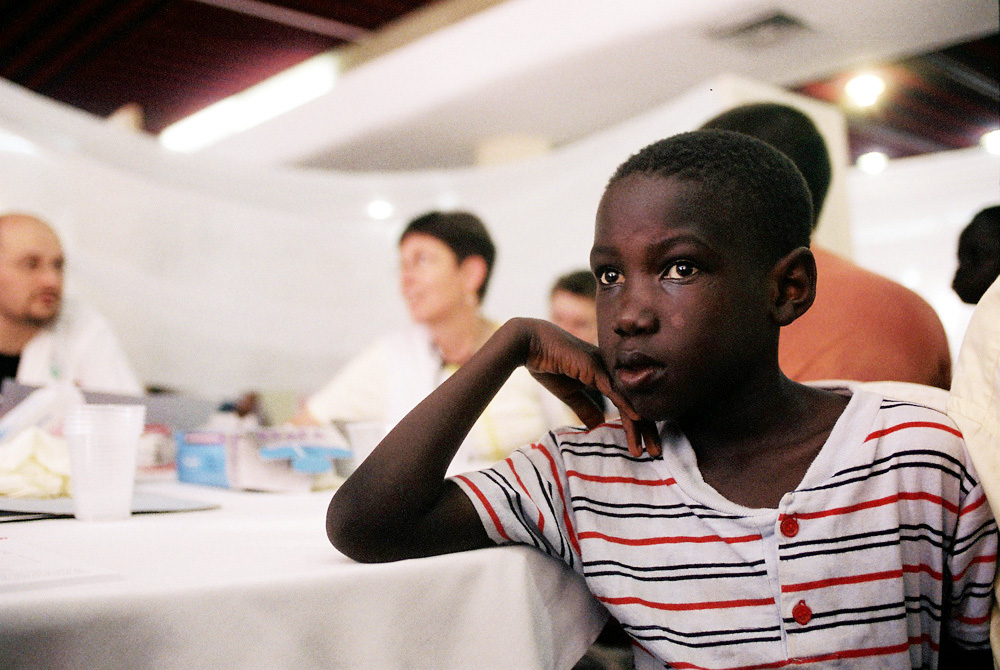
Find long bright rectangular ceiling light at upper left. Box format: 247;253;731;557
160;53;339;152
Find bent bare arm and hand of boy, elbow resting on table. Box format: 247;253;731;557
327;319;640;562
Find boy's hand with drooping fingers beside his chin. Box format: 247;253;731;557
518;319;662;457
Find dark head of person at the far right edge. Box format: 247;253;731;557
951;205;1000;305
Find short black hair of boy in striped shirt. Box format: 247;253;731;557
608;130;813;263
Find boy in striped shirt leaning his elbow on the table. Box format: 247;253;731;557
327;130;997;670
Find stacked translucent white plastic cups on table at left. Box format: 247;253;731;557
63;405;146;521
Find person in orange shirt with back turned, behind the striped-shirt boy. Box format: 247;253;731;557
702;103;951;389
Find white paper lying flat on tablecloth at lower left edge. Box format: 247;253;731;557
0;536;121;593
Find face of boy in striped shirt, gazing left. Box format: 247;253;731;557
590;174;778;421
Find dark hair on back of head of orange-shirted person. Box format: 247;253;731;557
702;102;832;227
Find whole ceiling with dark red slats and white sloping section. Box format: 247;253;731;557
0;0;1000;170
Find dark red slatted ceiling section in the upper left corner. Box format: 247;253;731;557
0;0;442;133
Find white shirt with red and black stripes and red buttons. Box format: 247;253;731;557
456;390;997;670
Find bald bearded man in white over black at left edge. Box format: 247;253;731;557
0;213;142;395
